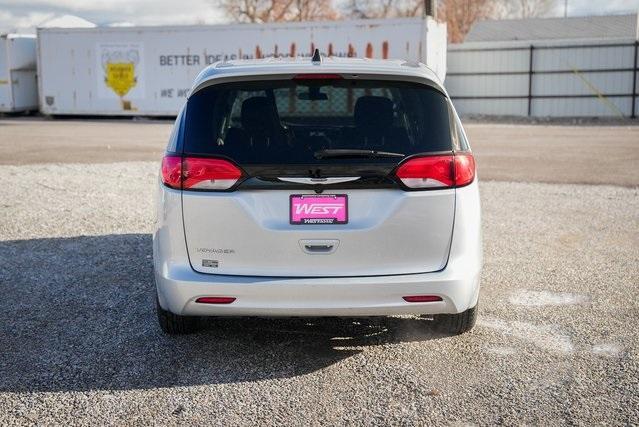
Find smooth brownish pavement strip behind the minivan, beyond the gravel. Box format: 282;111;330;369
0;118;639;187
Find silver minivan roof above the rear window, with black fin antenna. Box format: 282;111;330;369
191;57;446;93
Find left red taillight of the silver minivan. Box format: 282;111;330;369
162;155;242;190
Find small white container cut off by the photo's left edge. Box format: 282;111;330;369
0;34;38;113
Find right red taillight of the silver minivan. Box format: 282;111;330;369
395;152;475;189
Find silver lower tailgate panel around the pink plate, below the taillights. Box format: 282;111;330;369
182;189;455;277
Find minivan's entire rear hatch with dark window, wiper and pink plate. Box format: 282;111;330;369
178;75;455;277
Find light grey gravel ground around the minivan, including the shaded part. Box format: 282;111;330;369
0;162;639;425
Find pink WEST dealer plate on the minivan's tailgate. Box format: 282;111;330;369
290;194;348;224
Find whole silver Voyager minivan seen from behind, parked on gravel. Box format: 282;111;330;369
153;54;482;334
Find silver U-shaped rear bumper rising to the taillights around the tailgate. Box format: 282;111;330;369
153;182;482;316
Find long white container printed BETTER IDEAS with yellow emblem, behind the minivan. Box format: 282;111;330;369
38;18;446;116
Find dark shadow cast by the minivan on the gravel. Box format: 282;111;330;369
0;234;450;392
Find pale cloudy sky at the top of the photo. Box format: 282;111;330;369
0;0;639;31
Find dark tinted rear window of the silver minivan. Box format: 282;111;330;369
184;79;451;164
